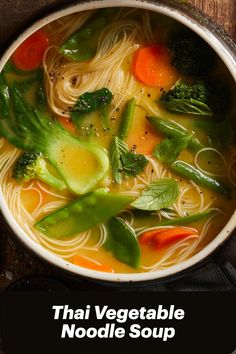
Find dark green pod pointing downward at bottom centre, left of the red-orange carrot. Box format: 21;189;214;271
104;217;141;268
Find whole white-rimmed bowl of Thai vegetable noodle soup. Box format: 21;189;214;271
0;0;236;282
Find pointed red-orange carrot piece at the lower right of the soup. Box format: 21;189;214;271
139;227;198;249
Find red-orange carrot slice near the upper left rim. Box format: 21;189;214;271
12;31;49;71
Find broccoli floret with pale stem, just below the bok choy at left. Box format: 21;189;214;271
13;151;67;191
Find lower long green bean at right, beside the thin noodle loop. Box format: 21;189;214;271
170;160;229;196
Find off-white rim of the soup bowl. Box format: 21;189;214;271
0;0;236;283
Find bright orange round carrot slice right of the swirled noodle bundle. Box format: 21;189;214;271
132;44;179;89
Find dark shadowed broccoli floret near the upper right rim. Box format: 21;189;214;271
168;29;216;76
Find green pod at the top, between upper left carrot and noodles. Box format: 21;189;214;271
59;9;113;62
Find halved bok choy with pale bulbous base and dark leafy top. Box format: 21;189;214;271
0;74;109;194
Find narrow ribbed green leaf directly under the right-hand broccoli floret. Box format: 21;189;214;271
162;98;213;116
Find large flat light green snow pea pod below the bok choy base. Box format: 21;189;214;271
35;188;133;238
